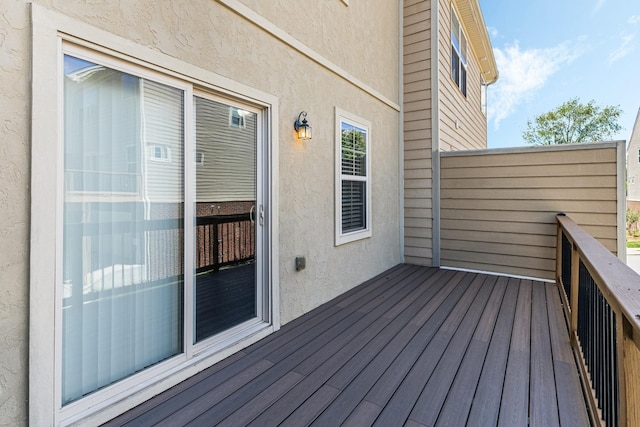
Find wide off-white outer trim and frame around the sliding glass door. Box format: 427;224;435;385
29;4;280;425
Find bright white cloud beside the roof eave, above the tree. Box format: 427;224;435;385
487;42;581;129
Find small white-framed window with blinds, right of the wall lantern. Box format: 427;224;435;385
336;108;371;245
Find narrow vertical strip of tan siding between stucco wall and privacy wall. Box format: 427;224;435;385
403;0;433;265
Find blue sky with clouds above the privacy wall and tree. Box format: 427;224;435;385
480;0;640;148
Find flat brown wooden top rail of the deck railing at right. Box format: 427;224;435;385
557;215;640;337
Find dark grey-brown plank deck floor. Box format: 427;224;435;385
102;265;589;427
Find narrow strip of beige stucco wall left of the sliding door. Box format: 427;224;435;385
0;1;30;426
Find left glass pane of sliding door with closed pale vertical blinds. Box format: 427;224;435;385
61;55;184;405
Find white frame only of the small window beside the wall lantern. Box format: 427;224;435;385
335;107;372;246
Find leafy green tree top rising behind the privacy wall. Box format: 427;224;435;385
522;98;622;145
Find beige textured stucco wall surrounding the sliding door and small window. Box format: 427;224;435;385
0;0;401;425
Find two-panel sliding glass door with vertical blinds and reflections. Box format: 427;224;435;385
62;55;267;406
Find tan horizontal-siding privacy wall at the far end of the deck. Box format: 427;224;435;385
441;142;624;279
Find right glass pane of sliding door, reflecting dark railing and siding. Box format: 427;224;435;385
194;97;260;342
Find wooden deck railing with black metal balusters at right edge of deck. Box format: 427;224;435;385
556;214;640;426
